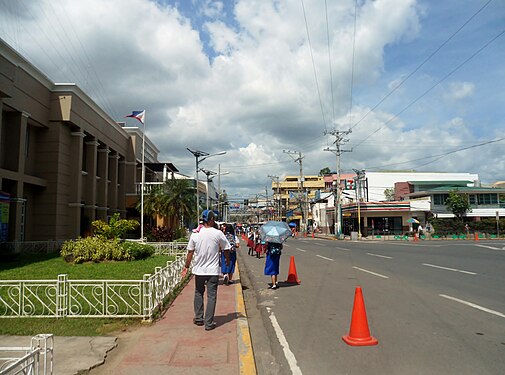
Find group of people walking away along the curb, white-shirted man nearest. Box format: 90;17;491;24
183;214;282;331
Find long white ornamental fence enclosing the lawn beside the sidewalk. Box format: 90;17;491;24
0;243;186;320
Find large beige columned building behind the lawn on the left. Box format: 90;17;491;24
0;40;136;241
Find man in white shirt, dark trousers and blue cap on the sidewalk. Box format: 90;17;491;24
184;210;231;331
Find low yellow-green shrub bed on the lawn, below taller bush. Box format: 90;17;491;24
60;237;133;263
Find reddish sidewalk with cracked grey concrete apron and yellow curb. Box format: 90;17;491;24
0;267;252;375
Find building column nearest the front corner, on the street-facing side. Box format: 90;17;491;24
68;131;86;238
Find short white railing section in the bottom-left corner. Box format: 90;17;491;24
0;334;54;375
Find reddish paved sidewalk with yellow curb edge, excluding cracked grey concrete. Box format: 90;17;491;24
88;267;256;375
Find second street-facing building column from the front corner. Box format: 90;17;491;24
84;140;99;232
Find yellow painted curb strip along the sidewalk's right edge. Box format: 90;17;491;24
234;261;256;375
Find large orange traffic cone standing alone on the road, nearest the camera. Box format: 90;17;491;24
342;286;379;346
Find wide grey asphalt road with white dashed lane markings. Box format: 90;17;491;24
240;238;505;375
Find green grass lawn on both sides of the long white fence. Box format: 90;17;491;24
0;254;183;336
